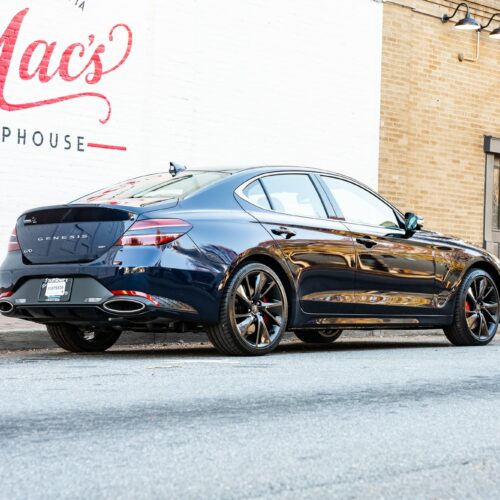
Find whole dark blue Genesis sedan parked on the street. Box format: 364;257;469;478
0;164;500;355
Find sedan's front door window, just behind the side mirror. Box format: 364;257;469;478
322;176;399;228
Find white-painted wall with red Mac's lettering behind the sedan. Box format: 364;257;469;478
0;0;382;253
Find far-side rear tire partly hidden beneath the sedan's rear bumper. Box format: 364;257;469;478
47;323;121;352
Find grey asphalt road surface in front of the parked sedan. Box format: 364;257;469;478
0;337;500;500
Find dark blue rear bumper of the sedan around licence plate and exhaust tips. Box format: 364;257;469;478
0;235;226;324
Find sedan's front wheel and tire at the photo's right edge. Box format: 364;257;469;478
444;269;500;346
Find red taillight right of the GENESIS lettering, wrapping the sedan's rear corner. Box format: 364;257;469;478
115;219;192;246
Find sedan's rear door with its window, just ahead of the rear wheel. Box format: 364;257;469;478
237;173;355;315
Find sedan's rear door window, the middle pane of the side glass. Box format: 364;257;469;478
261;174;326;218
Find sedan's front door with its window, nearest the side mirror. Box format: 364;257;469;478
322;176;436;317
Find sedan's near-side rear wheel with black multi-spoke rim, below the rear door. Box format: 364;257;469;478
207;262;288;356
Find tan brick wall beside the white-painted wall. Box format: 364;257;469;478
379;0;500;244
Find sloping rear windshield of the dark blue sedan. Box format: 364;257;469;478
72;171;230;205
